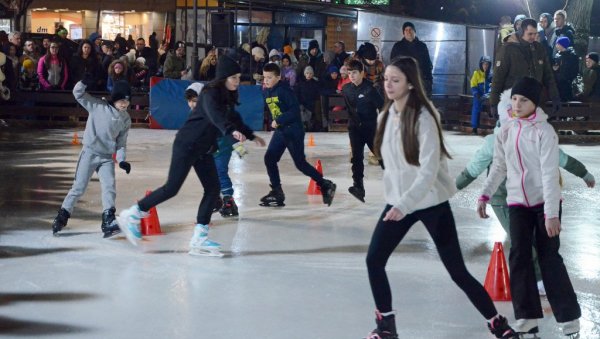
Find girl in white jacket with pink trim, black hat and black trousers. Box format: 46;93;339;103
477;77;581;338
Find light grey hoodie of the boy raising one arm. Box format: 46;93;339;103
73;81;131;162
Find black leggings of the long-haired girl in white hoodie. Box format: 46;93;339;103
367;201;498;319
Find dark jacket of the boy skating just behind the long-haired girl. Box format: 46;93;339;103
342;80;384;127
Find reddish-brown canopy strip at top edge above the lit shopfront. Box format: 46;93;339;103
29;0;176;12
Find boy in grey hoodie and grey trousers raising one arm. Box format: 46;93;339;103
52;74;131;238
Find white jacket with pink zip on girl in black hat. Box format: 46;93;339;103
480;90;561;218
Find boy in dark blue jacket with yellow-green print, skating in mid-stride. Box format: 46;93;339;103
260;63;336;207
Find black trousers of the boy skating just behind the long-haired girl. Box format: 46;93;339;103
348;123;377;187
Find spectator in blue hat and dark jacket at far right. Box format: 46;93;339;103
552;36;579;101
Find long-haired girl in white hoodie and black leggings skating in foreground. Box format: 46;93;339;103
367;57;517;339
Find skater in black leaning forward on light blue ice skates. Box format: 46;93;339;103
118;55;264;256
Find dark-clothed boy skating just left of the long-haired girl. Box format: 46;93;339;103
342;60;383;202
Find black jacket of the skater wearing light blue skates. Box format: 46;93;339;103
173;85;254;154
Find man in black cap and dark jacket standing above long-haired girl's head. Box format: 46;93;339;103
390;21;433;96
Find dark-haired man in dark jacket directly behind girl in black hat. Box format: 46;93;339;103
490;18;560;114
